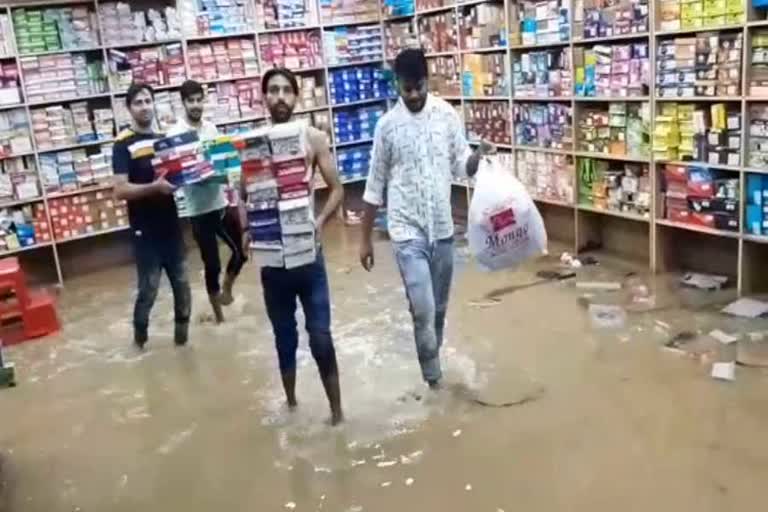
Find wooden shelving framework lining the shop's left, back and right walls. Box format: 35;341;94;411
0;0;768;293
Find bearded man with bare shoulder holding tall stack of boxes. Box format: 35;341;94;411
248;68;344;425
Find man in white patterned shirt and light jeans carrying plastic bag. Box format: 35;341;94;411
360;49;493;388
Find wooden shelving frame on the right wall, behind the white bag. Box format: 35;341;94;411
384;0;768;294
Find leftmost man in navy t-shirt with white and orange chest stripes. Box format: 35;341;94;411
112;84;192;348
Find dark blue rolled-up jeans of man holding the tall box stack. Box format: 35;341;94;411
261;252;338;377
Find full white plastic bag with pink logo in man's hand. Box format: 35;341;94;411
468;158;547;270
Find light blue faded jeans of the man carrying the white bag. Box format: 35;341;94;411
394;238;453;382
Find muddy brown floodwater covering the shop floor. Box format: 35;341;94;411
0;231;768;512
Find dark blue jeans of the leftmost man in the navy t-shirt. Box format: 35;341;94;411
133;233;192;332
